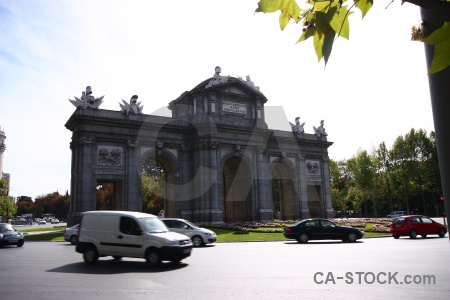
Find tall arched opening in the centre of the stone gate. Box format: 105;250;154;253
222;156;253;223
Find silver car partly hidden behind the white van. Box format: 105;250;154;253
161;218;217;247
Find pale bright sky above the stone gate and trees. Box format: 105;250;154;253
0;0;434;199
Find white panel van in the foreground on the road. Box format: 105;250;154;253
76;210;192;266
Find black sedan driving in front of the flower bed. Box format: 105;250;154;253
283;219;363;243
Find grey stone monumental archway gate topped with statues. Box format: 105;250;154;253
65;75;334;224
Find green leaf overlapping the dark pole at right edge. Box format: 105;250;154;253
423;22;450;74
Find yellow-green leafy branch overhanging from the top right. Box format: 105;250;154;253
256;0;450;73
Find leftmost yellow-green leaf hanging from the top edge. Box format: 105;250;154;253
255;0;301;30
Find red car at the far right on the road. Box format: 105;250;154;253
390;215;447;239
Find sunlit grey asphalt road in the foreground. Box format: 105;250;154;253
0;237;450;300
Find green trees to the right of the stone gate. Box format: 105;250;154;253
330;129;444;217
